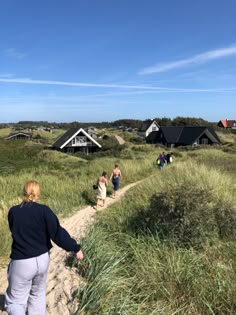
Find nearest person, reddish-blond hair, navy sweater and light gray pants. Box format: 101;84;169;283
5;180;83;315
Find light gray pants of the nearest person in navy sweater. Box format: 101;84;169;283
5;253;49;315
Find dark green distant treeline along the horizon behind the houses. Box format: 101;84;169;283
0;116;216;129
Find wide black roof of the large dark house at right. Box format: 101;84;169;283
147;126;220;145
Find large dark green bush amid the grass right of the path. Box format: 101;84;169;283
129;182;236;247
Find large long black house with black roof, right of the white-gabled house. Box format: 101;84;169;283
146;126;220;148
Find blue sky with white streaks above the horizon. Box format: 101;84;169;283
0;0;236;122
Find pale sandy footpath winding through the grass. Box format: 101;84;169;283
0;183;137;315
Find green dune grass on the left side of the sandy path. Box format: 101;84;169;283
0;140;159;255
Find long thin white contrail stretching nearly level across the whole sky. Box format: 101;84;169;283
0;78;234;94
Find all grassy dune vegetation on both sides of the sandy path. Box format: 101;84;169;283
0;127;236;315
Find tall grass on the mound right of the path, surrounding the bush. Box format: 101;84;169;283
75;159;236;315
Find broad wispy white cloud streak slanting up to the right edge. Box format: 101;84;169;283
138;45;236;75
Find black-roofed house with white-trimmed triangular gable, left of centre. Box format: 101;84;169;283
52;128;102;154
